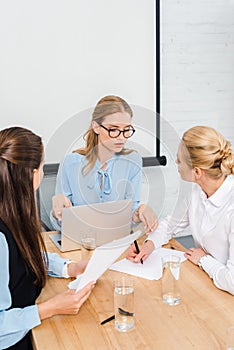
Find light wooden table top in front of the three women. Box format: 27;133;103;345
32;233;234;350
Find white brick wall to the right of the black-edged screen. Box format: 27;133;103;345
142;0;234;235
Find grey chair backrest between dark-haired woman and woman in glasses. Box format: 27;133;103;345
36;163;59;231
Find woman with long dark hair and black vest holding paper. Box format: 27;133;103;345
0;127;93;350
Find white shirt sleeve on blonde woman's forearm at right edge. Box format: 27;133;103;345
202;213;234;295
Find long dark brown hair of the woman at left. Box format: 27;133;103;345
0;127;47;287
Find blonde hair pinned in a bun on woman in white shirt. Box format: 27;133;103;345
182;126;234;179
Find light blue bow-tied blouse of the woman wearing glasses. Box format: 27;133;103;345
51;151;142;230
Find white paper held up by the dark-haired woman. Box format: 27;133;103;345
68;231;142;292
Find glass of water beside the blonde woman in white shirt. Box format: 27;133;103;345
162;255;180;305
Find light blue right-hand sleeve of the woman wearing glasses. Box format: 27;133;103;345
126;152;142;213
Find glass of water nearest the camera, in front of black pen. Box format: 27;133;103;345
114;276;135;332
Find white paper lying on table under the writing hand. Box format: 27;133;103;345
109;248;186;280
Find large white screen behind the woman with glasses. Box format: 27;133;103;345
0;0;156;162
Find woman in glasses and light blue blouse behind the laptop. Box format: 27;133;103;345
51;96;157;232
